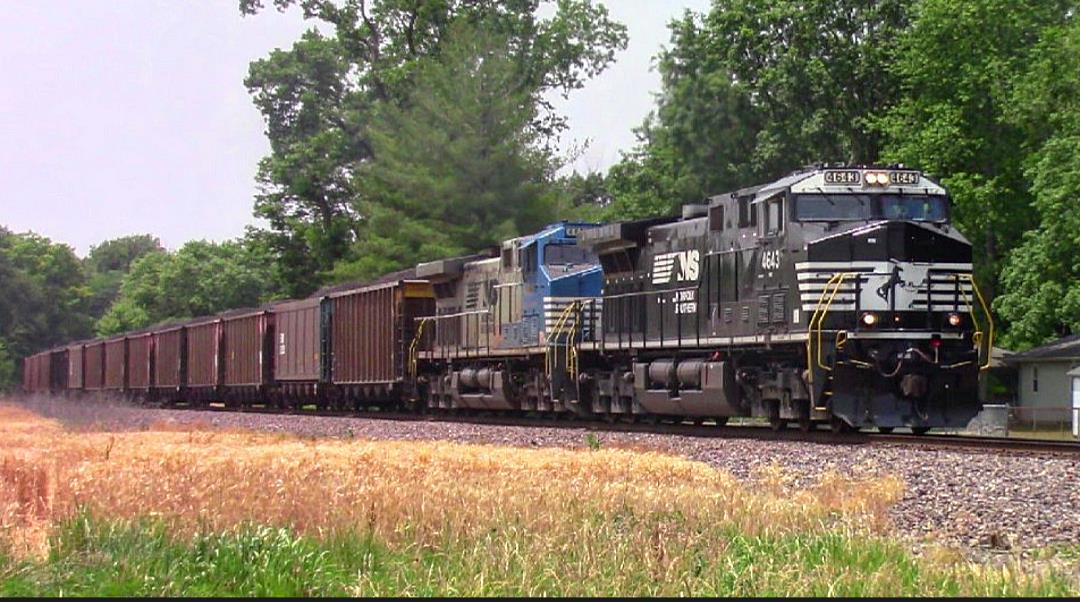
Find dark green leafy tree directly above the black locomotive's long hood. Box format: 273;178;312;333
608;0;909;218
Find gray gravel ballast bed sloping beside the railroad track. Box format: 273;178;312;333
10;400;1080;551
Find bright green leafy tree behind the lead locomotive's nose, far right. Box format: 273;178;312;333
878;0;1075;296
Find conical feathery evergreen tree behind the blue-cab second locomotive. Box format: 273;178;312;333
332;23;555;278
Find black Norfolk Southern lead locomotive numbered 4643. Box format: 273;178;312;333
578;168;993;431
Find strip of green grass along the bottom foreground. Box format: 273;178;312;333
0;513;1080;597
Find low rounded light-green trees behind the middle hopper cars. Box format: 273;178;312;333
97;241;272;336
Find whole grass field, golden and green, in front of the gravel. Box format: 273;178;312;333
0;406;1080;596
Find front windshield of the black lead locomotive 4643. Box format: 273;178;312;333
795;195;948;222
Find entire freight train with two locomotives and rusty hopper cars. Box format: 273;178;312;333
24;166;994;433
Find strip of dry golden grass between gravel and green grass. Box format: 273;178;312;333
0;405;903;557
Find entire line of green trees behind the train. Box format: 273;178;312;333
6;0;1080;386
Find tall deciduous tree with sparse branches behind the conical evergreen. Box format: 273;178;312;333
240;0;626;296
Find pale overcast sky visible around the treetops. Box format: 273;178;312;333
0;0;708;255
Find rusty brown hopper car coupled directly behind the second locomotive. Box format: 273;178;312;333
328;280;435;406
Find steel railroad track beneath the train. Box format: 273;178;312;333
156;404;1080;455
